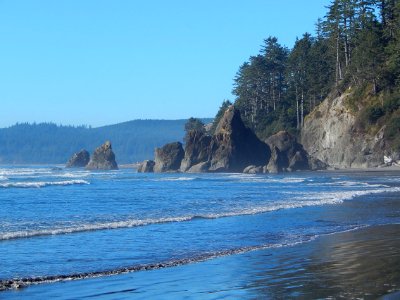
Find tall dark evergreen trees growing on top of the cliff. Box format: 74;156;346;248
233;0;400;138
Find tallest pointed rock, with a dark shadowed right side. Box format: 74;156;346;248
209;105;271;172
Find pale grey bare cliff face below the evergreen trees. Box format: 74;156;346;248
301;93;387;168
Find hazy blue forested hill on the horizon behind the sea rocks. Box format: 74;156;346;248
0;119;212;164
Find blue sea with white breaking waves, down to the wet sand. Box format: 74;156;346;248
0;166;400;296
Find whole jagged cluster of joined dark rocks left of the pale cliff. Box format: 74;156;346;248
138;105;326;174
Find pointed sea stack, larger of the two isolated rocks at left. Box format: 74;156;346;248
86;141;118;170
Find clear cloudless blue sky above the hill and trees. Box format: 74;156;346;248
0;0;329;127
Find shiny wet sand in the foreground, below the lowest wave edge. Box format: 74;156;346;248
4;225;400;299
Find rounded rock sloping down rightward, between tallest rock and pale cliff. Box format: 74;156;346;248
265;131;326;173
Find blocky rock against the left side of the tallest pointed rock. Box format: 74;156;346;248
180;130;212;173
